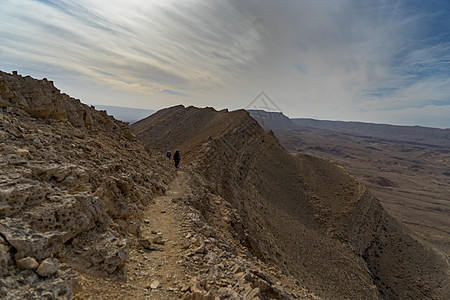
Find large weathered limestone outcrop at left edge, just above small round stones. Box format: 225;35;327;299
0;194;108;259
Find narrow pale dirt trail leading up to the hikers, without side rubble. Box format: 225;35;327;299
75;171;189;299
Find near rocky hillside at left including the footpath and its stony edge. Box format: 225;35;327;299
0;72;320;299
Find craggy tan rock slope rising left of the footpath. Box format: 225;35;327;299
0;72;172;299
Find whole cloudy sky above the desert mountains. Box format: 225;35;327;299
0;0;450;128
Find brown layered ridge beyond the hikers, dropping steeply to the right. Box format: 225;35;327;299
132;106;449;299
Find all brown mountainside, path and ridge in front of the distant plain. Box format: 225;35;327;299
0;72;449;300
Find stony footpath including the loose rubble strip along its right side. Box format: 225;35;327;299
75;170;319;300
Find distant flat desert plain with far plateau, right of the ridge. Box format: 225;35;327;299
252;111;450;256
